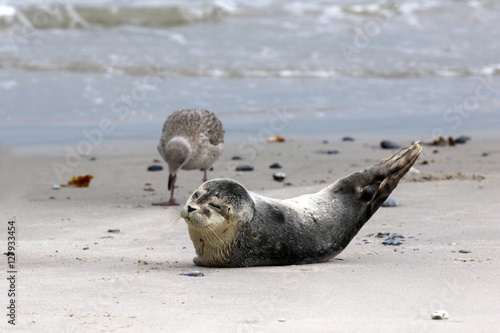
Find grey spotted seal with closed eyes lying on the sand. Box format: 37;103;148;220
181;142;422;267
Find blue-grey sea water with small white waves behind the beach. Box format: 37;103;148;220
0;0;500;146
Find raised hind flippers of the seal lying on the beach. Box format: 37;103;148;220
359;142;422;211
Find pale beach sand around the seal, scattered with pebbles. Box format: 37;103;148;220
0;137;500;332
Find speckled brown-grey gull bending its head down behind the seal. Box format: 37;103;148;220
153;109;224;206
